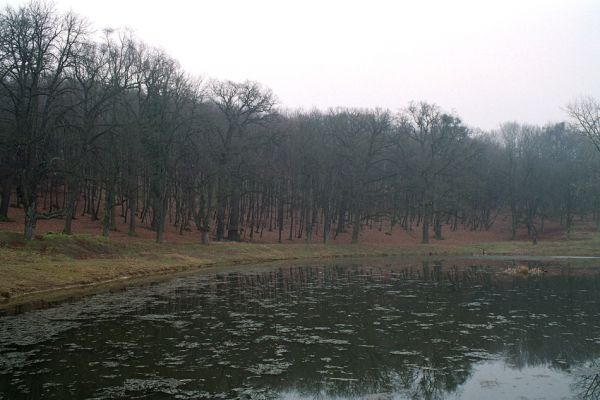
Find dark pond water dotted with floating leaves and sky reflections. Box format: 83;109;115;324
0;261;600;400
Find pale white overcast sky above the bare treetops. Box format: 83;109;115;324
5;0;600;129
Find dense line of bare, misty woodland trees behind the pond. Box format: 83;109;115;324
0;2;600;243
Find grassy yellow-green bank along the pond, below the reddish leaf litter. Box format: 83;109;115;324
0;232;600;305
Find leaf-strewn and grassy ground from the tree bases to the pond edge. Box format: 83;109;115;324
0;208;600;307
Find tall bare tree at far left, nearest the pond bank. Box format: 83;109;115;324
0;2;86;240
